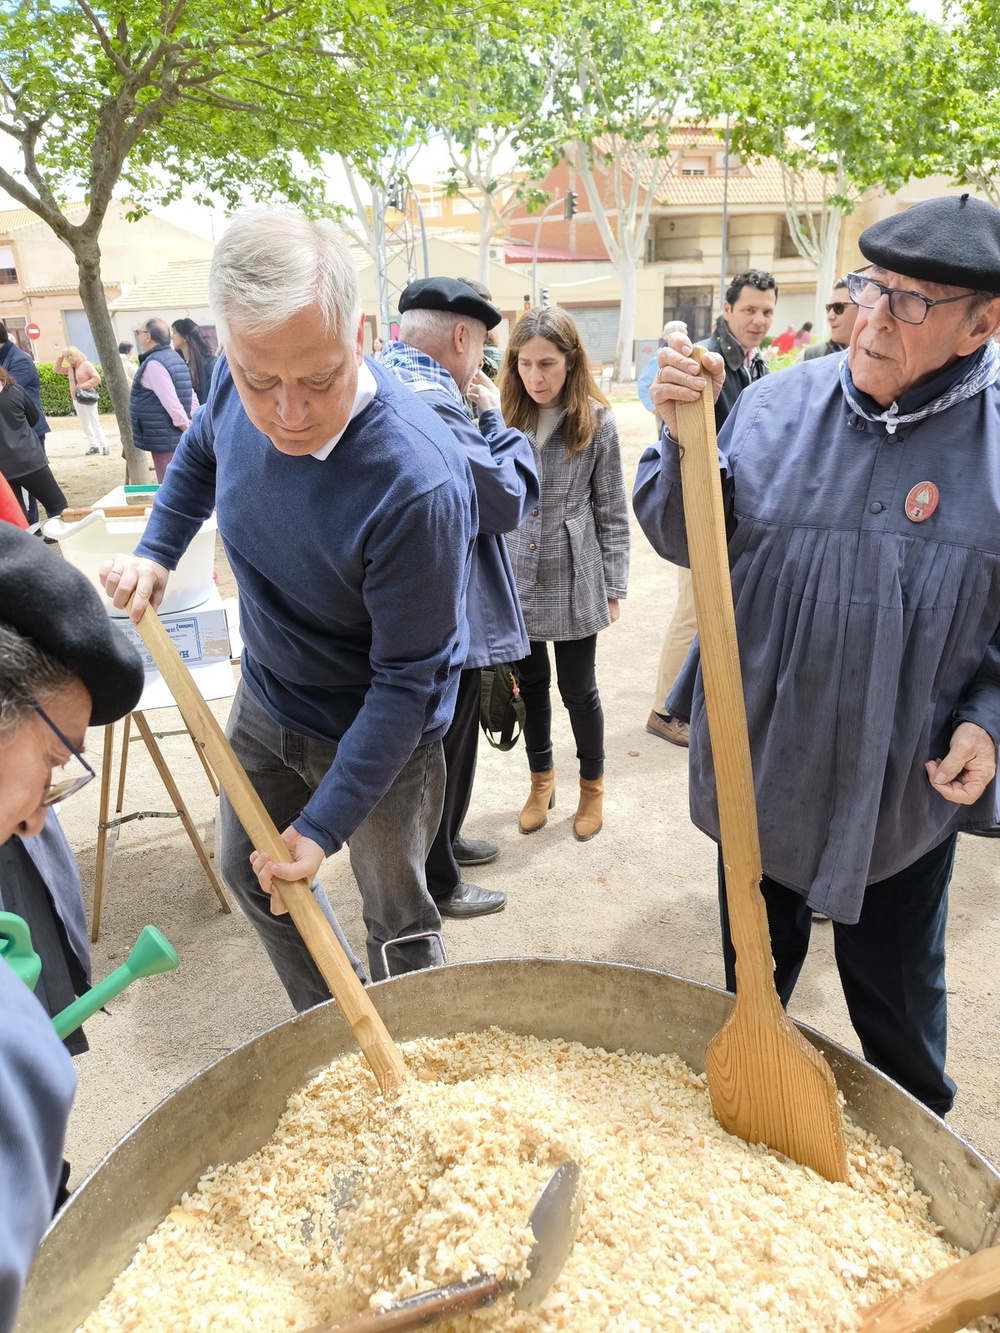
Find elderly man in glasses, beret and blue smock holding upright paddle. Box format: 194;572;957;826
635;195;1000;1114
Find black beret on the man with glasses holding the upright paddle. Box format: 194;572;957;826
857;195;1000;292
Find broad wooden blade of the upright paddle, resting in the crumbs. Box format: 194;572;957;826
705;994;847;1181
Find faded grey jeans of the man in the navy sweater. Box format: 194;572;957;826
225;681;444;1012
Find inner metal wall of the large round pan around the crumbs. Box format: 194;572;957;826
16;960;1000;1333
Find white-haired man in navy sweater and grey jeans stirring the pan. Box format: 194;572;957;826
104;209;477;1009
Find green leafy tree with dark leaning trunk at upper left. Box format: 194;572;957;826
0;0;453;480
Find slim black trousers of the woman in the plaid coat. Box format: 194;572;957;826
517;635;604;780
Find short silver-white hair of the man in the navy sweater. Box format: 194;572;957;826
208;208;361;343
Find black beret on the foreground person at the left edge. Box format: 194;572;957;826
0;523;145;726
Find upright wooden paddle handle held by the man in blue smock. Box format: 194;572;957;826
676;347;777;1002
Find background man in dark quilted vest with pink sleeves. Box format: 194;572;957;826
128;320;197;481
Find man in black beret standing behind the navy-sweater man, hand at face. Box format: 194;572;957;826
379;277;539;917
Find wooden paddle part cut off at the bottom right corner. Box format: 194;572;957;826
860;1245;1000;1333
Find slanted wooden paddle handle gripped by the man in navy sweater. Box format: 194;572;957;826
136;609;408;1097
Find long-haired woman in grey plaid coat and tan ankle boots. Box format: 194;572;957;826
500;305;628;841
